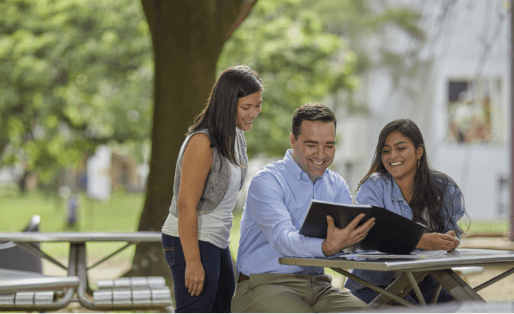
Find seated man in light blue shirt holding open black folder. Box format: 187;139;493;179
231;104;374;312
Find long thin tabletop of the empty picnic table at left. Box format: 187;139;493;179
0;231;162;243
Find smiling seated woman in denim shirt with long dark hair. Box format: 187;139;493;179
345;119;465;303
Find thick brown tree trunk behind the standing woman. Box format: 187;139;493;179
124;0;257;278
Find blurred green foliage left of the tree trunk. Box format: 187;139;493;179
0;0;153;182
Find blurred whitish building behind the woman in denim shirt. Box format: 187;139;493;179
332;0;510;220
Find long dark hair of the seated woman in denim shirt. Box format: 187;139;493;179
357;119;464;234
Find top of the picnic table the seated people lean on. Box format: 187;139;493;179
278;249;514;271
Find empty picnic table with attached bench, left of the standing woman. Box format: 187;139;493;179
0;232;172;311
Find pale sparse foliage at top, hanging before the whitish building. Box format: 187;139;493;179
302;0;425;91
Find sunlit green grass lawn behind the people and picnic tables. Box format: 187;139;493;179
0;189;509;258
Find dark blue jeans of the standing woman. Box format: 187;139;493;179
162;234;236;313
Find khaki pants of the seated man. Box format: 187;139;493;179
231;274;369;313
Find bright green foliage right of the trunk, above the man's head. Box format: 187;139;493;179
218;0;358;156
